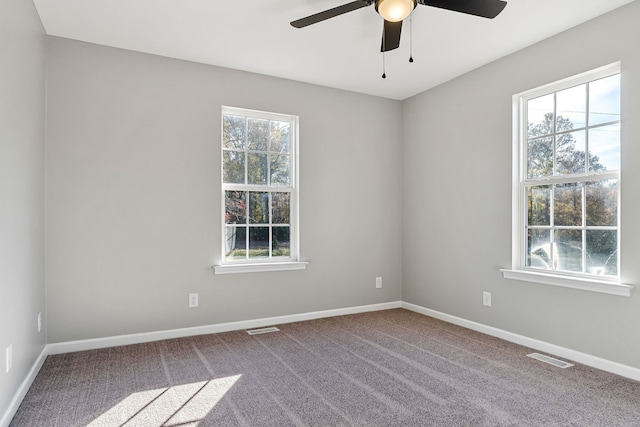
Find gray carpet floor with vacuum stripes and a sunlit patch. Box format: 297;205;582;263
11;309;640;427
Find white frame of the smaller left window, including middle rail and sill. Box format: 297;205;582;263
214;106;307;274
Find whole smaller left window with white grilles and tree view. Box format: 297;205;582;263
215;107;304;273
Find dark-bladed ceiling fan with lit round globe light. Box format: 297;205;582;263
291;0;507;52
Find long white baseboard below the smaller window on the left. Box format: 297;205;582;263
47;301;402;354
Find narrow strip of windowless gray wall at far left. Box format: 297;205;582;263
0;0;46;417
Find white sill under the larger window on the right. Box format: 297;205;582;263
500;269;634;297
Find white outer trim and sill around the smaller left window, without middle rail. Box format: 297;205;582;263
213;105;308;274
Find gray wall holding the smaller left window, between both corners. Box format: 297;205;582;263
46;37;402;343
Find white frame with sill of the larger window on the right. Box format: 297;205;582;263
501;62;634;296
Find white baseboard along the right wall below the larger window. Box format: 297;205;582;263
402;302;640;381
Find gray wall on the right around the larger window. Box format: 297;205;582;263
403;1;640;368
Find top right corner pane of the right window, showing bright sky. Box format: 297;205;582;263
589;74;620;126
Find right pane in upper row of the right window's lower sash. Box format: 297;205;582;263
586;179;618;226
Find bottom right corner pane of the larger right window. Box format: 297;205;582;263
587;230;618;276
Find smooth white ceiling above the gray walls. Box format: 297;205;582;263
34;0;633;99
